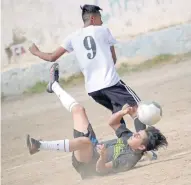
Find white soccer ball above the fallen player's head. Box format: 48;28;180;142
137;101;162;126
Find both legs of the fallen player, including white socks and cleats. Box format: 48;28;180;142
27;63;93;162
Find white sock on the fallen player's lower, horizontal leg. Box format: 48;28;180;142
39;139;70;152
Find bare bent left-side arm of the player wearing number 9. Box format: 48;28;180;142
29;44;67;62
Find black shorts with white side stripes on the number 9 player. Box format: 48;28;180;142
88;80;141;113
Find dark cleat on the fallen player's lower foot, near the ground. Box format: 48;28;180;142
27;135;40;155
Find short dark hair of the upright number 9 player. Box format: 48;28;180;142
80;4;102;23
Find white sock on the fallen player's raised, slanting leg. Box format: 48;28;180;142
52;82;78;112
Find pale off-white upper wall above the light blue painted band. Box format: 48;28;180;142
1;0;191;71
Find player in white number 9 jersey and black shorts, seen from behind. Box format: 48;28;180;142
29;5;157;159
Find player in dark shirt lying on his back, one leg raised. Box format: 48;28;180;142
27;64;168;178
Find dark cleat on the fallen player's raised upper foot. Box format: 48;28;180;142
47;63;59;93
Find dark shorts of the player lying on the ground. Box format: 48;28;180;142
72;124;99;179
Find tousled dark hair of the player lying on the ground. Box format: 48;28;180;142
144;127;168;151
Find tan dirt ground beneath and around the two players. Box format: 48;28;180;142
1;60;191;185
